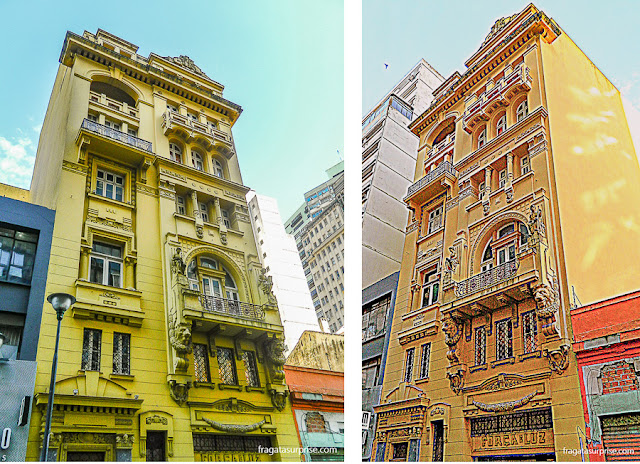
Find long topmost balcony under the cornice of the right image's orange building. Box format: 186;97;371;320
462;64;532;133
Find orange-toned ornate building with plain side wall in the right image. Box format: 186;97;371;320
372;5;640;461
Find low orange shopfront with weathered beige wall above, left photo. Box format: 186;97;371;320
284;331;344;462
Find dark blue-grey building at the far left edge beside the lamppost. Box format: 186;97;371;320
0;184;54;462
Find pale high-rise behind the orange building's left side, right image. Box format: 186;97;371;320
362;59;444;289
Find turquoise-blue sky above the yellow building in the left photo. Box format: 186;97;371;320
0;0;344;220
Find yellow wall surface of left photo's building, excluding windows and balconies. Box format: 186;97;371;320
27;30;299;461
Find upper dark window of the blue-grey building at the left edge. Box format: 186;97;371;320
0;227;38;284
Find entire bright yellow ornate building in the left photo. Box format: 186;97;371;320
27;30;300;461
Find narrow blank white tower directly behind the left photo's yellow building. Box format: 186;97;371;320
247;191;319;355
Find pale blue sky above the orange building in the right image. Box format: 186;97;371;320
362;0;640;115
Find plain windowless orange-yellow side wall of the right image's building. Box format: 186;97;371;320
542;29;640;304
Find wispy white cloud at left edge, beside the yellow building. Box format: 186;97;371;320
0;136;36;189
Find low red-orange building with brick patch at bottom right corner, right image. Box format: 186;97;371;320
571;291;640;461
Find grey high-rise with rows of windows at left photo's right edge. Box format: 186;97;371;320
285;161;344;333
